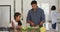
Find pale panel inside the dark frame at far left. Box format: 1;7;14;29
0;5;11;27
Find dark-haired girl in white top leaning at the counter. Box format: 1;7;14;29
11;12;22;30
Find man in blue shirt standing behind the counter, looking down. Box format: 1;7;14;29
27;1;45;26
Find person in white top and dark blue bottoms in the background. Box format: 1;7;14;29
51;6;57;30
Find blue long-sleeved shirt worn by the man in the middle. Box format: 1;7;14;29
27;8;45;25
